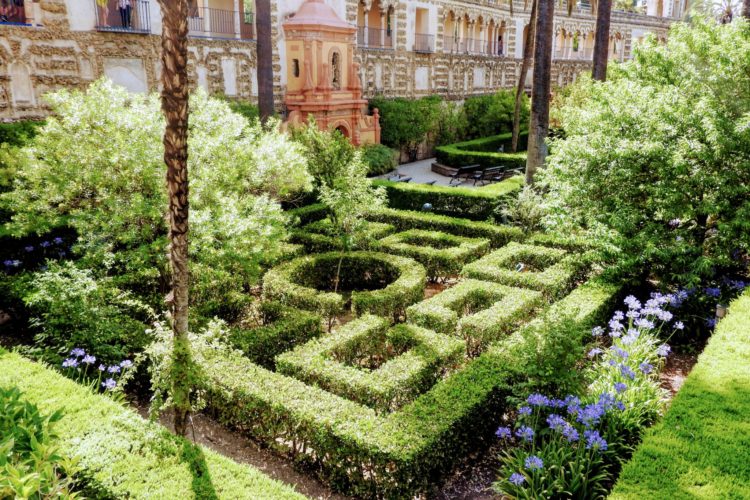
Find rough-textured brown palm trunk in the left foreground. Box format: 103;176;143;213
159;0;191;436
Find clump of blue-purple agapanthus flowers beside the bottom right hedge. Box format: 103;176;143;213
494;293;684;498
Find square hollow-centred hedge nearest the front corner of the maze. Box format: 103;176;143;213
276;315;465;412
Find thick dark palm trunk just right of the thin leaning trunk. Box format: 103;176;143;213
526;0;555;184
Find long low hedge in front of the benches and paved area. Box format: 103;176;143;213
372;177;521;220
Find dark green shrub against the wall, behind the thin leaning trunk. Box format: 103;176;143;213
464;90;529;138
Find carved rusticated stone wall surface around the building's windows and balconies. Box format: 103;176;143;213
0;0;670;120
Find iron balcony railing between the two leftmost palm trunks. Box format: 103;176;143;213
188;7;255;40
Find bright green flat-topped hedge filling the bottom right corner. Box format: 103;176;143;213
610;291;750;500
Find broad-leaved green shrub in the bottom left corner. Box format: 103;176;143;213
0;386;78;498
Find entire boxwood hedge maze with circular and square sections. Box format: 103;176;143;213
197;209;616;498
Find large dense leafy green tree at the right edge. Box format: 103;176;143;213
541;20;750;285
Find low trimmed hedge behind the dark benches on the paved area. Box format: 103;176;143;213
435;132;528;169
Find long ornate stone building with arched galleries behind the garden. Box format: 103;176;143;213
0;0;686;120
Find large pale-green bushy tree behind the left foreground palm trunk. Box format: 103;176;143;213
0;80;310;315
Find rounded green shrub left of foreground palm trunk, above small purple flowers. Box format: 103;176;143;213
23;262;154;364
